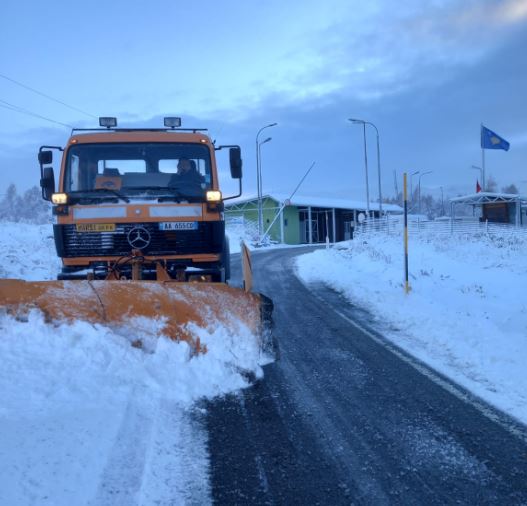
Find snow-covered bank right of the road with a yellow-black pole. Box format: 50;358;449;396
297;233;527;423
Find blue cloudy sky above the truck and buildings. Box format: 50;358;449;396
0;0;527;201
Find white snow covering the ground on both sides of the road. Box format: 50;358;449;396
4;219;527;505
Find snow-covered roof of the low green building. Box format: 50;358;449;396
225;193;403;213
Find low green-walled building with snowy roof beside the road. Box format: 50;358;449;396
225;193;403;244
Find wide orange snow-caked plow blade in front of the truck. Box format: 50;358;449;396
0;279;272;353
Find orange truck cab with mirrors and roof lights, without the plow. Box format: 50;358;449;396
39;118;242;281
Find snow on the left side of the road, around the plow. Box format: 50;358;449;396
0;223;266;506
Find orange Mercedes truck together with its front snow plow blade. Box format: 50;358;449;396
0;117;272;353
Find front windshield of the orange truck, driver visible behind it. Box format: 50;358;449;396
64;143;212;197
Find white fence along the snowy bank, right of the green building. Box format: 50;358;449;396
354;216;527;238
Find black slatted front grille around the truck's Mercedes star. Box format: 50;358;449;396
61;222;223;257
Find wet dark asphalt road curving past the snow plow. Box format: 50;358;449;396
205;249;527;505
